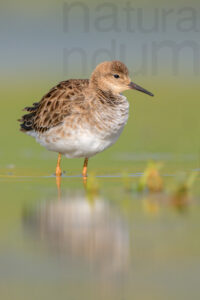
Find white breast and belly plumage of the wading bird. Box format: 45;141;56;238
29;96;129;158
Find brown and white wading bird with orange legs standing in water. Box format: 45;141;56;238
19;61;153;177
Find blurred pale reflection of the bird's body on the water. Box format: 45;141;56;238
24;178;129;274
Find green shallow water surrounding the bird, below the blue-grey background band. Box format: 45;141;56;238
0;78;200;300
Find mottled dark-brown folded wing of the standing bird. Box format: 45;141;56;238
19;79;89;132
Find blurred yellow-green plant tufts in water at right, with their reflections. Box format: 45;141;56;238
134;162;198;215
